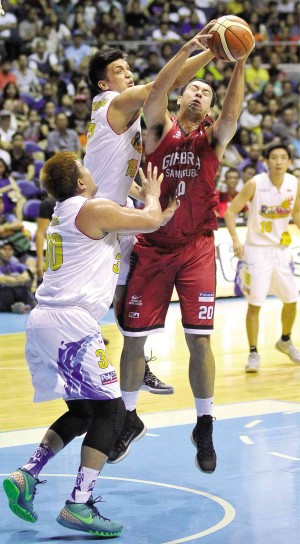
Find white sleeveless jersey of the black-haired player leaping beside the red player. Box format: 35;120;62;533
84;91;142;206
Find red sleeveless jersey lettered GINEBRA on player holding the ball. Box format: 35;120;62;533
138;117;220;245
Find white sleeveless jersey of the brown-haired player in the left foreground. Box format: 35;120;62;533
36;196;120;321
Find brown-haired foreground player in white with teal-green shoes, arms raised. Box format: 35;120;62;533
3;151;163;537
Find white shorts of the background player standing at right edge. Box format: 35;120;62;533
239;244;299;306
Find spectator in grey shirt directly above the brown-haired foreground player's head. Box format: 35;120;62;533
45;112;82;158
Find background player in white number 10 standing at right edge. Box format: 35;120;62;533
225;144;300;372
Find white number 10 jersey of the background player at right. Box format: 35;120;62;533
246;173;298;246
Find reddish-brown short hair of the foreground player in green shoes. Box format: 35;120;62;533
40;151;79;201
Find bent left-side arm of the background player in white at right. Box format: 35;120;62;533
224;179;256;259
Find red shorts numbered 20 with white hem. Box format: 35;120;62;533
117;236;216;336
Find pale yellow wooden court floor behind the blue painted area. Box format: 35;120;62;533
0;298;300;431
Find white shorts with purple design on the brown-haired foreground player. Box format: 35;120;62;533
25;305;121;402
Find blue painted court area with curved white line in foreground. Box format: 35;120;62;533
0;408;300;544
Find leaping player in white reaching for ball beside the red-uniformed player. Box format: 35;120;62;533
84;26;214;394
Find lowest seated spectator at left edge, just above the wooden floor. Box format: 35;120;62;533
0;240;36;313
